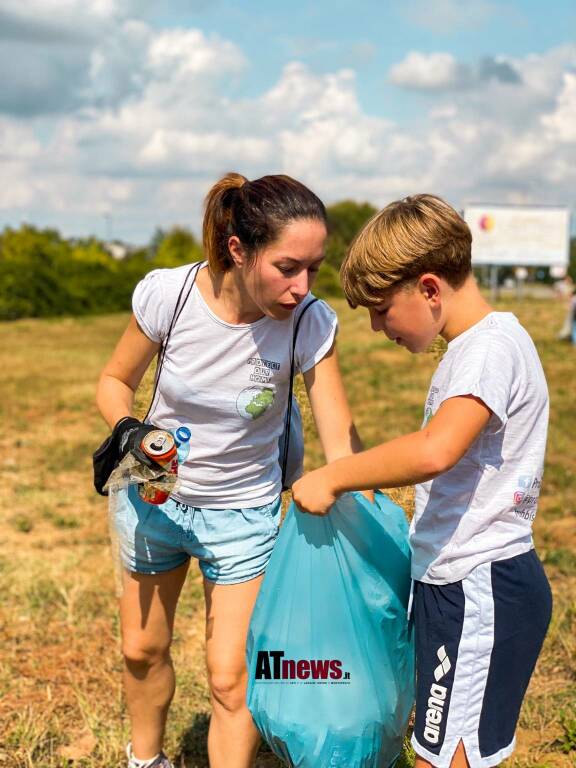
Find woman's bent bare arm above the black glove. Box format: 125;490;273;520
96;315;160;429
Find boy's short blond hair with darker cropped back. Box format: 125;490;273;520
340;195;472;307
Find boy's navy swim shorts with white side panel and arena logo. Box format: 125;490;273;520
412;549;552;768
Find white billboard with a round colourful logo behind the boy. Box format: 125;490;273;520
464;204;570;267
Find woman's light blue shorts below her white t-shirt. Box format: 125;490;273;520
114;486;281;584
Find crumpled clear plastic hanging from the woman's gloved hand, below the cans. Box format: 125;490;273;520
104;453;179;598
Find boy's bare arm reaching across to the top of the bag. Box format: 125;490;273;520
292;395;492;515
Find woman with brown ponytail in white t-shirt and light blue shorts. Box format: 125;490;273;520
98;174;361;768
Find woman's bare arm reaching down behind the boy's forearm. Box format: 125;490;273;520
304;345;363;463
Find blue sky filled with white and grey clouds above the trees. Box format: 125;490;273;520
0;0;576;244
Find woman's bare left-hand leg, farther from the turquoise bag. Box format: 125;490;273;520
120;561;189;760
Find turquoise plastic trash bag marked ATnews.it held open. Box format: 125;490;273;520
247;493;414;768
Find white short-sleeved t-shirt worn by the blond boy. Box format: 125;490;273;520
410;312;548;584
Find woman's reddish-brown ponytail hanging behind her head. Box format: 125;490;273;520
202;173;248;275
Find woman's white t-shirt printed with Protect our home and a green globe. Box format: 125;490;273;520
132;265;337;509
